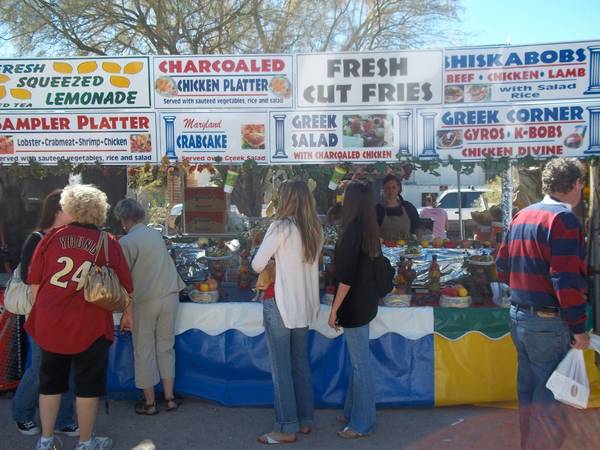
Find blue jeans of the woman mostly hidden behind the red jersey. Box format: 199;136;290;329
11;338;75;429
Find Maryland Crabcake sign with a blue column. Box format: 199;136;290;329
159;111;268;164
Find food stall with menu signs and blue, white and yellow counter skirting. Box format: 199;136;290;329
0;42;600;406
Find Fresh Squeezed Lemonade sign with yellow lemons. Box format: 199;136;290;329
0;57;150;110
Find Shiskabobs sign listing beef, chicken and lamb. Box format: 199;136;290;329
444;41;600;104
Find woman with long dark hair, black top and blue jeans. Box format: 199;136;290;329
329;181;381;438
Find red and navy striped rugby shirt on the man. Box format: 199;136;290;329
496;196;587;334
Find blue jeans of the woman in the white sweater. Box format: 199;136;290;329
263;299;315;433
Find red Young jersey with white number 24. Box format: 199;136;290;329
25;224;133;355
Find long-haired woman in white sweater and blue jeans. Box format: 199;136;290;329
252;181;323;444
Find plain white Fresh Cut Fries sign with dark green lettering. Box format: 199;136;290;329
296;50;443;108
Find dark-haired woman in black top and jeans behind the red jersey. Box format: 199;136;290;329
12;189;79;436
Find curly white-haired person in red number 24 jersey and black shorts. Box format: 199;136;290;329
25;185;133;450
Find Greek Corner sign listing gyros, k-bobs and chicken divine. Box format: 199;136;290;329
416;103;600;160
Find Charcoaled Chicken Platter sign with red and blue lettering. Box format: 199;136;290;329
153;55;293;109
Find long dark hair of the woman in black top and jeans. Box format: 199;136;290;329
341;181;381;256
